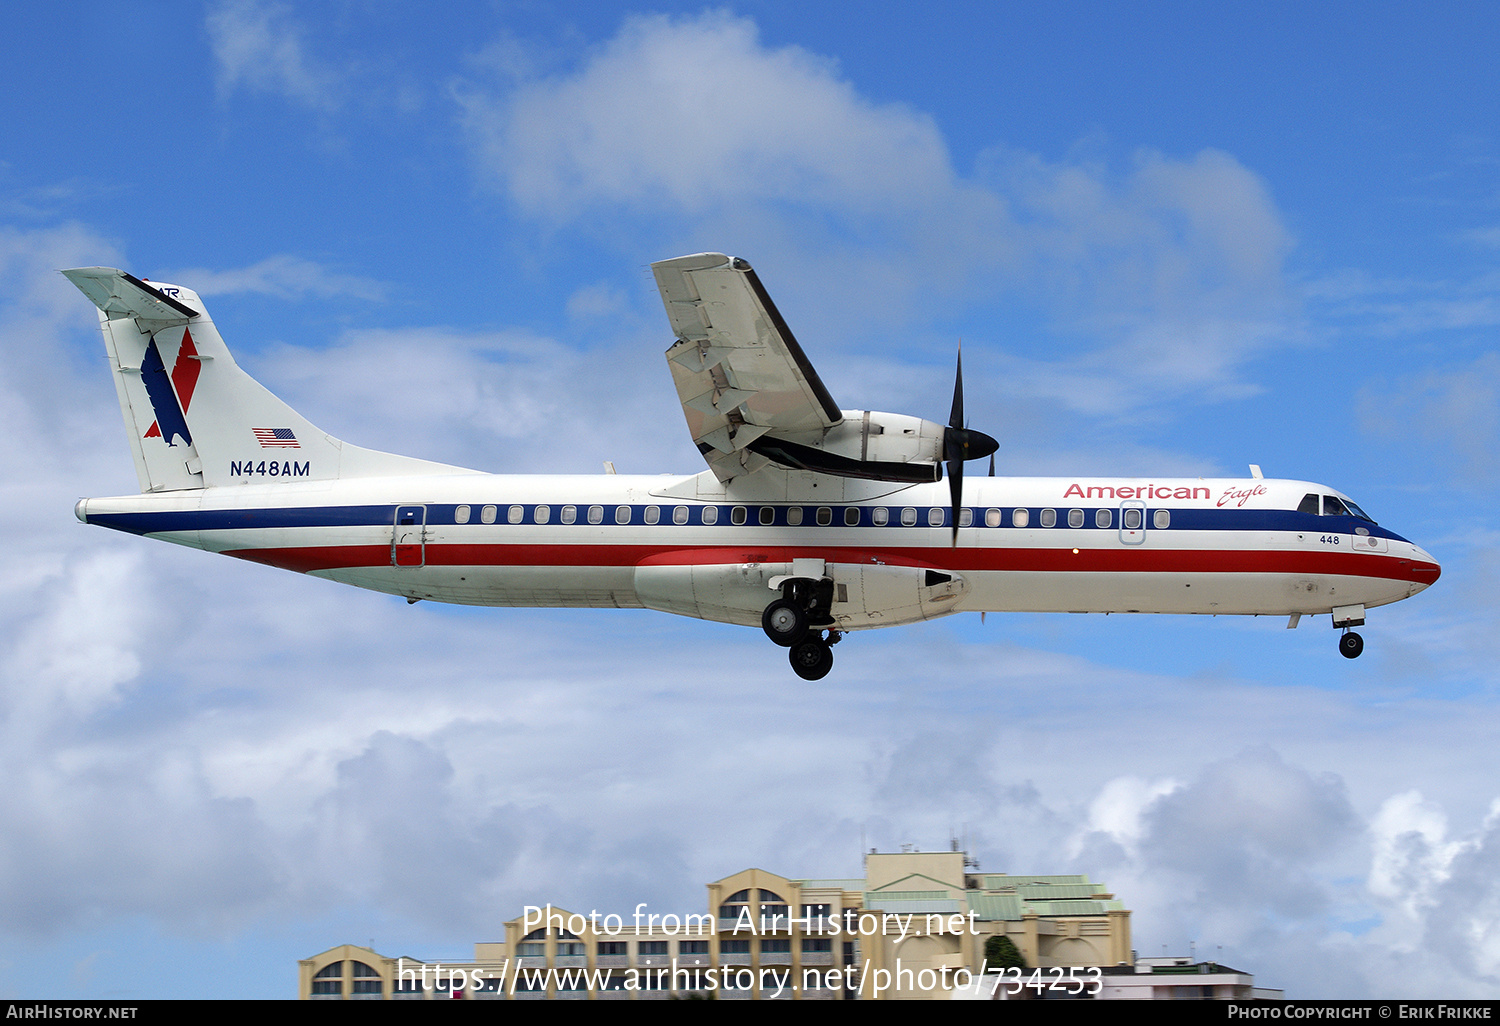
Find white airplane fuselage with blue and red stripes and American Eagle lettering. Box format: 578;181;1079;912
78;473;1439;630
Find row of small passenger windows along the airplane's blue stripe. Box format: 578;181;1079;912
453;497;1176;531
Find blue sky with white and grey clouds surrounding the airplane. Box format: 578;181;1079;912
0;0;1500;999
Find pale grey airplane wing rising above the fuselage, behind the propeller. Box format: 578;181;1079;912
651;254;843;482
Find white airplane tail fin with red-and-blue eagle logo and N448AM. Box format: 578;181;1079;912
63;267;473;492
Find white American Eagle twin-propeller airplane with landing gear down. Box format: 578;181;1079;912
63;254;1440;681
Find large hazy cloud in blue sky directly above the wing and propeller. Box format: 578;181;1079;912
458;14;1298;414
